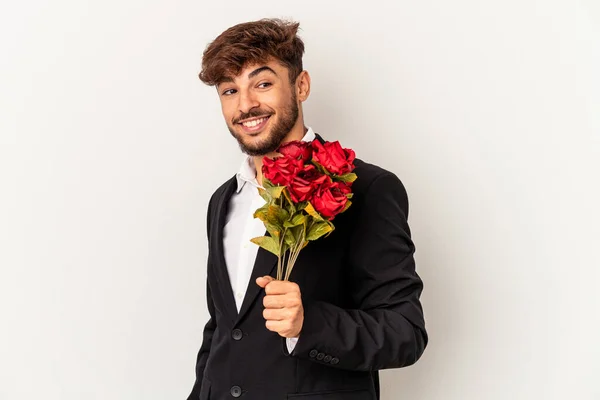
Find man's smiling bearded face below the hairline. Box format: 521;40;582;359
217;61;298;156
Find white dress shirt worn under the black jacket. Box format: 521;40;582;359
223;127;316;353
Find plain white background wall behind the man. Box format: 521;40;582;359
0;0;600;400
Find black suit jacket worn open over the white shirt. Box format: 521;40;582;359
188;135;427;400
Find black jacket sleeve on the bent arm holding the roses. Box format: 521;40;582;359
292;171;428;371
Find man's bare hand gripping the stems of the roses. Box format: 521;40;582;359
256;276;304;338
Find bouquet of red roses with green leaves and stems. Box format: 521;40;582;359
251;139;356;281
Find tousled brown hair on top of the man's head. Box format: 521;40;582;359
198;18;304;86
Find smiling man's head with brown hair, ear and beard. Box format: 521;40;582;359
199;19;310;156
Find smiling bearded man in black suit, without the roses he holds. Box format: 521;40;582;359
188;19;427;400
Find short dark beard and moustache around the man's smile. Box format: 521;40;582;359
227;91;298;156
